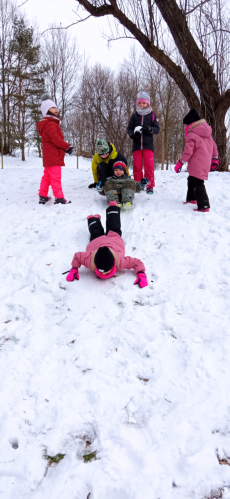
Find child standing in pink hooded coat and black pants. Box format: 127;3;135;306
174;109;219;212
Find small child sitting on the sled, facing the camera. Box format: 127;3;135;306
104;161;143;209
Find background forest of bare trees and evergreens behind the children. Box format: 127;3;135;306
0;0;228;168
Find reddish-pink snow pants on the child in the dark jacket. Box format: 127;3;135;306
133;149;155;187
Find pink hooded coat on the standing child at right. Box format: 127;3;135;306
180;120;218;180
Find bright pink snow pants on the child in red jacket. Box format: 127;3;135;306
39;166;64;198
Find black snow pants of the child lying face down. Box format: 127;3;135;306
88;206;122;242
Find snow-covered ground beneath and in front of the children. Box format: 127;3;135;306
0;157;230;499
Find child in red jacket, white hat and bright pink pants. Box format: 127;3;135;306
37;95;73;204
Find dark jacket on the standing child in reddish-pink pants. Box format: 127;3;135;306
127;112;160;152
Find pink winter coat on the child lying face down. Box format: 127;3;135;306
72;230;145;274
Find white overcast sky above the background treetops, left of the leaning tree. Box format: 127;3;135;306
21;0;138;69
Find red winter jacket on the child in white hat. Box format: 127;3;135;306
37;117;69;167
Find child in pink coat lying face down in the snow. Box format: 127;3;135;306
66;201;148;288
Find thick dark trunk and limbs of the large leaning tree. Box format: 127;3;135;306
76;0;230;171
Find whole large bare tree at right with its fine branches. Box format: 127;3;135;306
76;0;230;170
